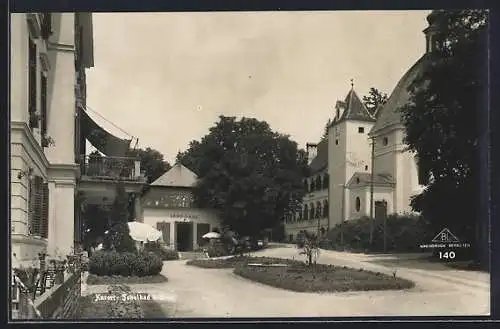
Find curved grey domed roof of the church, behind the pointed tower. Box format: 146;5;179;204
370;54;430;135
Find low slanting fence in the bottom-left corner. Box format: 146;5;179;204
12;273;82;320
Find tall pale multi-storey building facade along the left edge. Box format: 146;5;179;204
10;13;93;265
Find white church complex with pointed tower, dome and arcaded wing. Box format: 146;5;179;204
285;14;436;240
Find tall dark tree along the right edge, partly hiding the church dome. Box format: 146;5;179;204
401;10;488;266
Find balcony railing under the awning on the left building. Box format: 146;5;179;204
80;155;146;182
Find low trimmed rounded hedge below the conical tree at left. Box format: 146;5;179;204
89;251;163;276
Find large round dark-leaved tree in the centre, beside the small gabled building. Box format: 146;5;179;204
177;116;307;236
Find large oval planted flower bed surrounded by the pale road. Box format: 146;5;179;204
234;260;415;292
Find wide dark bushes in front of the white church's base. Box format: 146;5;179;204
321;214;436;252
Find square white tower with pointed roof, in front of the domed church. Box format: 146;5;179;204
328;80;375;227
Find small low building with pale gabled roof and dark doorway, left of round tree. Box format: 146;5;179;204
137;163;221;251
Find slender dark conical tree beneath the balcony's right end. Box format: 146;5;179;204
104;181;136;252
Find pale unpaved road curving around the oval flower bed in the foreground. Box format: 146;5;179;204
84;246;490;318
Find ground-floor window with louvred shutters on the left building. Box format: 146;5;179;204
28;176;49;238
